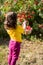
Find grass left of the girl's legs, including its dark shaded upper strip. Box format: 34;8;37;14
0;39;8;65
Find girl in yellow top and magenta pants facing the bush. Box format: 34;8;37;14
4;12;24;65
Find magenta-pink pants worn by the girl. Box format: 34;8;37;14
8;40;21;65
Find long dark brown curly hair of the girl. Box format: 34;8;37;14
4;12;17;29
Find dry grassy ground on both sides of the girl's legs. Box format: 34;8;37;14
0;39;43;65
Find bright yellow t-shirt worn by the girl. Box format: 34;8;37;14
7;25;24;42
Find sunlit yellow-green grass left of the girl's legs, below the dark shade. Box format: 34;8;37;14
0;45;8;65
